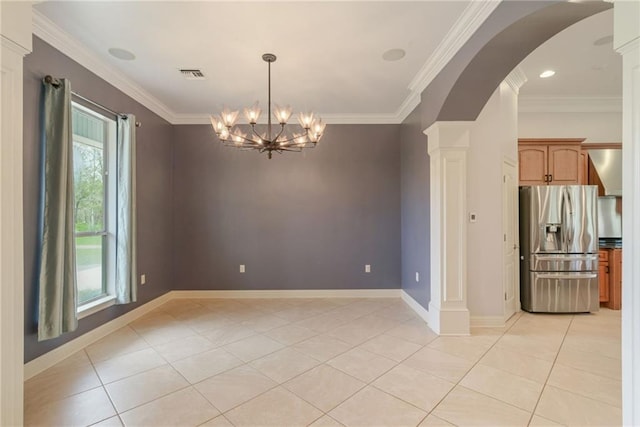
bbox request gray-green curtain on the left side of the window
[38,79,78,341]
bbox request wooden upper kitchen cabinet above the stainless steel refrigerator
[518,138,587,185]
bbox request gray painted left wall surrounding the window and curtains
[24,36,173,362]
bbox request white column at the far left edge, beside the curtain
[0,2,31,426]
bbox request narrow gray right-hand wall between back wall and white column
[400,106,431,309]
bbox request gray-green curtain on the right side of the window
[116,114,138,304]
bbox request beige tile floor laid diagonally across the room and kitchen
[25,298,622,427]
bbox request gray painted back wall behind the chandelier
[174,125,401,289]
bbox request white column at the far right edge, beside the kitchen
[613,0,640,426]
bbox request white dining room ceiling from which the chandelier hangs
[35,1,476,123]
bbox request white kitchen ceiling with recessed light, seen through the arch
[520,9,622,99]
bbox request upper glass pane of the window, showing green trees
[73,141,105,231]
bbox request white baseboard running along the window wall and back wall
[24,289,402,381]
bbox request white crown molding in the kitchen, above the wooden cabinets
[518,97,622,113]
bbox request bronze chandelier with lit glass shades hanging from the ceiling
[211,53,325,158]
